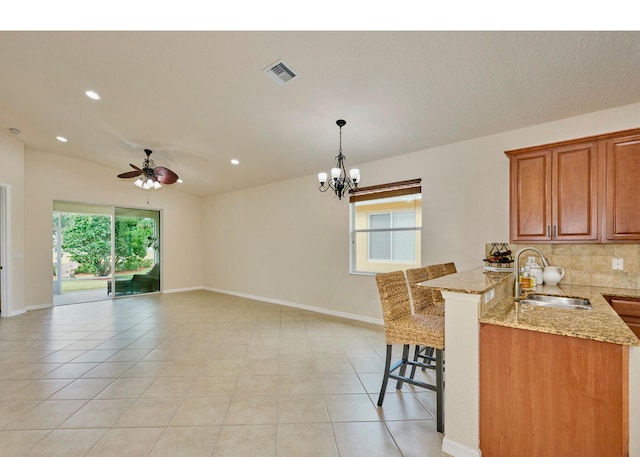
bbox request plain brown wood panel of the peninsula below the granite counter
[480,324,629,457]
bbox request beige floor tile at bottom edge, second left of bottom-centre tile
[149,427,220,457]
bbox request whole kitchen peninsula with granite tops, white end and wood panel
[421,268,640,457]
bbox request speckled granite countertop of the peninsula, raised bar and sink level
[421,268,640,346]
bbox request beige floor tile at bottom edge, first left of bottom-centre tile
[213,424,278,457]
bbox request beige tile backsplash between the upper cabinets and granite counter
[485,243,640,289]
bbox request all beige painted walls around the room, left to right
[0,100,640,322]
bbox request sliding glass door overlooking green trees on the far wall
[53,202,161,305]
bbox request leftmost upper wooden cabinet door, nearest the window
[510,151,552,241]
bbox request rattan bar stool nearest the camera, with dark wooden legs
[376,271,444,432]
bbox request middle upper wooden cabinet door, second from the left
[551,142,599,241]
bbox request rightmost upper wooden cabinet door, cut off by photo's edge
[606,135,640,241]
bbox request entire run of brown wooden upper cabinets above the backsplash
[505,125,640,243]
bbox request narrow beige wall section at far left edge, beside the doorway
[0,133,25,316]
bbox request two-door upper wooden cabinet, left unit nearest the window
[507,141,600,242]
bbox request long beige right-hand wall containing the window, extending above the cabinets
[204,104,640,321]
